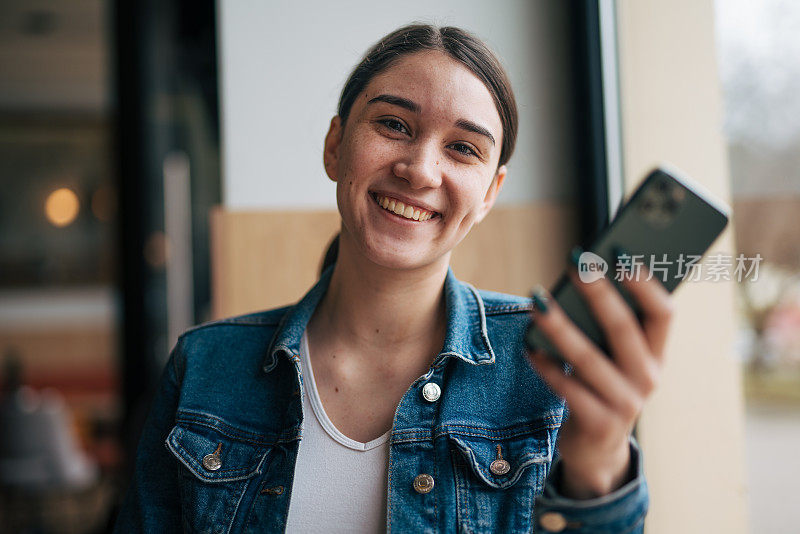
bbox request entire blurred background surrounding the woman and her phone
[0,0,800,534]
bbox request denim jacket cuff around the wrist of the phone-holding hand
[534,437,649,534]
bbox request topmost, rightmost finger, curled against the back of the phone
[621,265,675,362]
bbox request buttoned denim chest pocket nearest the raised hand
[448,429,552,533]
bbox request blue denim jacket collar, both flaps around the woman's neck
[262,266,494,372]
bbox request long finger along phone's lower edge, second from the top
[569,268,660,394]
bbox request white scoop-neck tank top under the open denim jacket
[286,332,391,534]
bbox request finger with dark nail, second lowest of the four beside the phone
[534,288,638,413]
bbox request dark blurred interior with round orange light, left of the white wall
[0,0,220,533]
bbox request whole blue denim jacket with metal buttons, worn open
[116,269,648,533]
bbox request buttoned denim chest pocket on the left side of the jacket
[166,422,270,533]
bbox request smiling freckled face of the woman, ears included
[324,51,506,269]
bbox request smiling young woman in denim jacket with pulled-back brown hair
[117,25,672,532]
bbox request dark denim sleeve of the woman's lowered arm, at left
[114,339,182,533]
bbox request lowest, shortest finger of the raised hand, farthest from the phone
[529,350,611,432]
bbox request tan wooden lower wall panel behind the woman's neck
[211,203,577,318]
